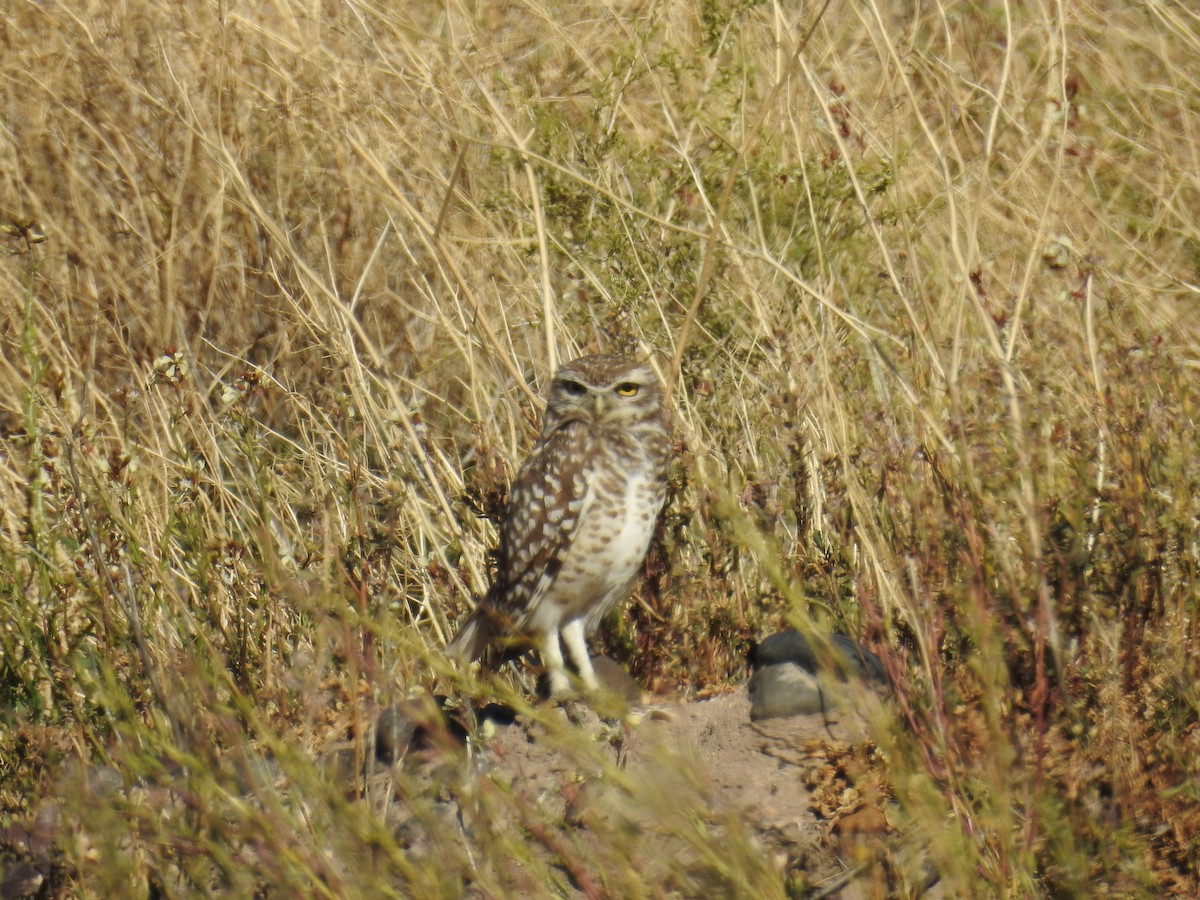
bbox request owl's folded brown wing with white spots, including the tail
[446,422,593,660]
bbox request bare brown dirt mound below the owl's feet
[372,686,937,900]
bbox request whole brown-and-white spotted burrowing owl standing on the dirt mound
[448,356,668,695]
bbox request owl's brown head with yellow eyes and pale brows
[544,355,662,432]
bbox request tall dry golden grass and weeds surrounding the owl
[0,0,1200,896]
